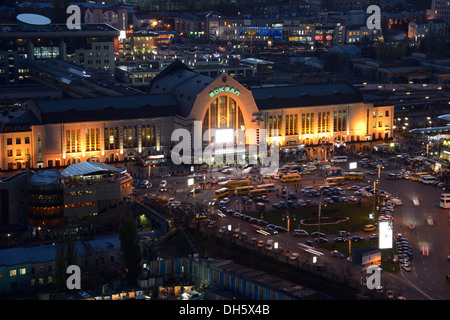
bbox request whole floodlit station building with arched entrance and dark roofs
[0,61,394,170]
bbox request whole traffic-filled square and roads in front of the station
[129,144,450,300]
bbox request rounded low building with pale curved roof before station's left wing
[24,162,133,228]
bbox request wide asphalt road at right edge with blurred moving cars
[381,179,450,300]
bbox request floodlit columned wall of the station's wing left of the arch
[27,117,167,168]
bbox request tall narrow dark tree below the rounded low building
[119,212,142,281]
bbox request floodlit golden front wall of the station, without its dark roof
[0,74,394,170]
